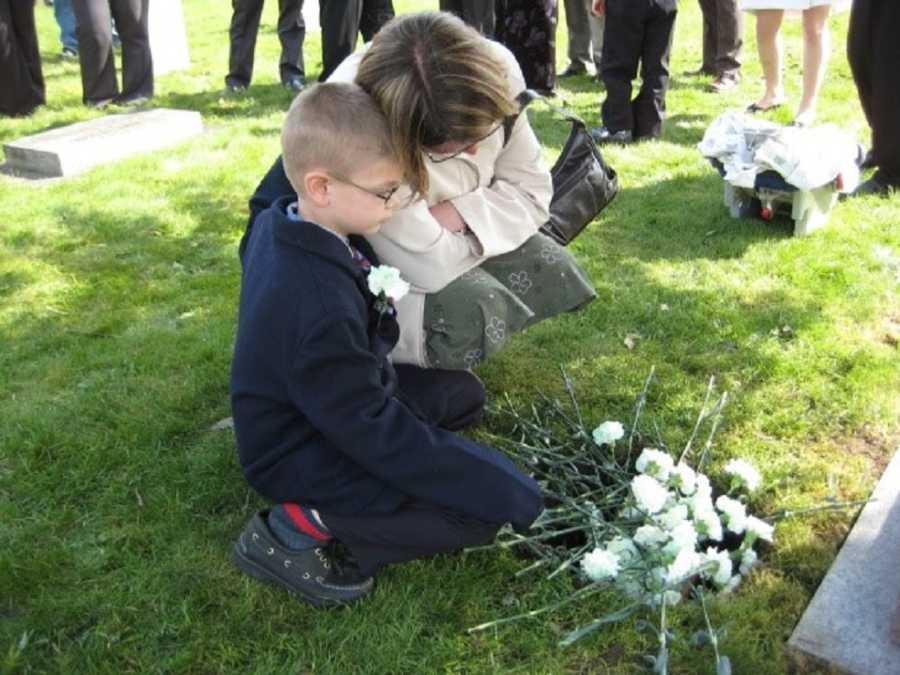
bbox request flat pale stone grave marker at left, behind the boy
[3,108,203,178]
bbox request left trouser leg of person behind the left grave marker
[72,0,119,103]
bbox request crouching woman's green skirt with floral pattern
[425,234,597,368]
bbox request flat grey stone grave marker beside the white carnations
[788,451,900,675]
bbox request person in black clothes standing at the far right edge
[847,0,900,196]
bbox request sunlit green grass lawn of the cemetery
[0,0,900,674]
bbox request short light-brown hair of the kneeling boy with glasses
[281,82,396,194]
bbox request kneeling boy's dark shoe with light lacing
[232,511,375,607]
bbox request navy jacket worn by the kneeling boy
[231,196,542,530]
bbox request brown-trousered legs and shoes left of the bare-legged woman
[696,0,744,94]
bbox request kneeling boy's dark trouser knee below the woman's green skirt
[394,364,485,431]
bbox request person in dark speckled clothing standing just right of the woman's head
[494,0,557,96]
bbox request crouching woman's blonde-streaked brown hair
[356,12,517,193]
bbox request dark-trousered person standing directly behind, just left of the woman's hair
[319,0,394,82]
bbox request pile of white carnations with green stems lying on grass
[470,371,774,675]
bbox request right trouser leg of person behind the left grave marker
[109,0,153,100]
